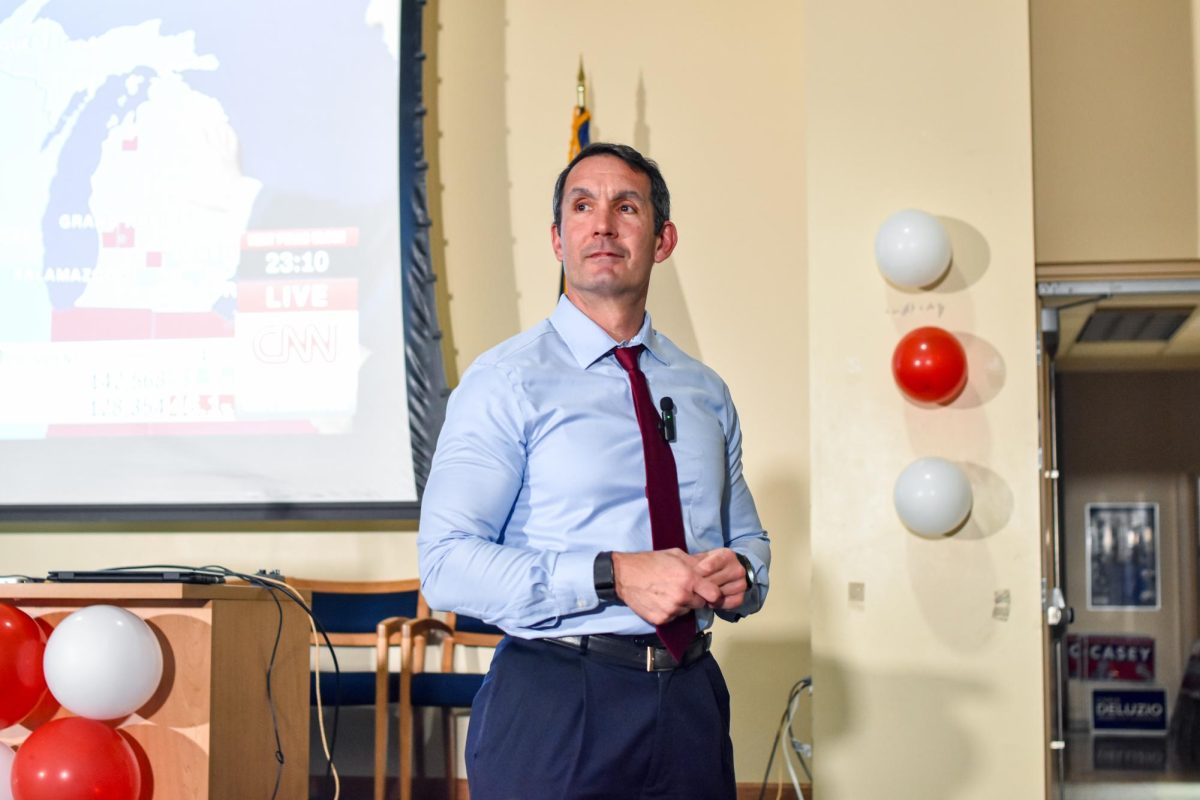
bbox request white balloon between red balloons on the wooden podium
[42,606,162,720]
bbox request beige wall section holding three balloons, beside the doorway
[803,0,1046,800]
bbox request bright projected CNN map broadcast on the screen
[0,0,400,440]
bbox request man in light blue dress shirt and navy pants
[418,144,770,800]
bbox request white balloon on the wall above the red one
[875,209,950,289]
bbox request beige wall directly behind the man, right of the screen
[430,0,810,782]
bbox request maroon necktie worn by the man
[614,344,696,662]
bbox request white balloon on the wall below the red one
[893,458,973,539]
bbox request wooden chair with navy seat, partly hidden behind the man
[400,599,504,800]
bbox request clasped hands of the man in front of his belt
[612,547,749,625]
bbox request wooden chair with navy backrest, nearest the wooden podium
[287,578,430,800]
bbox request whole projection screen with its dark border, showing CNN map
[0,0,445,521]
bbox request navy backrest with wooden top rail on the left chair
[287,578,428,646]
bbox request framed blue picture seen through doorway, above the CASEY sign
[1085,503,1162,610]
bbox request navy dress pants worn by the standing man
[467,637,737,800]
